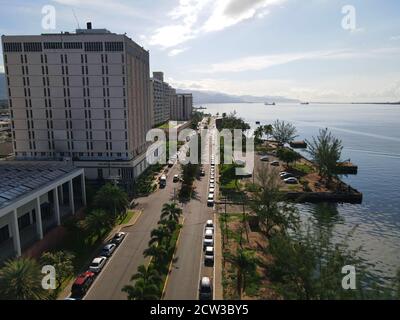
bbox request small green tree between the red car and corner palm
[40,251,75,290]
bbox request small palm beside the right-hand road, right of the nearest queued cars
[227,248,257,299]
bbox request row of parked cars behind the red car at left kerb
[67,232,126,300]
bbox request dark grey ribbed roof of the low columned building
[0,161,78,209]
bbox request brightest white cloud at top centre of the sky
[145,0,286,49]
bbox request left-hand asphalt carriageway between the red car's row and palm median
[85,164,183,300]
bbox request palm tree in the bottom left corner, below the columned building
[0,258,48,300]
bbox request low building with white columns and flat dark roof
[0,161,86,260]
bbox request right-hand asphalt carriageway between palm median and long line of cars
[164,120,214,300]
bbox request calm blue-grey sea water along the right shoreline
[203,104,400,280]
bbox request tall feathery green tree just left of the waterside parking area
[250,164,299,238]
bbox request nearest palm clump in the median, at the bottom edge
[122,265,161,300]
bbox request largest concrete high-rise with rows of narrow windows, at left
[2,23,157,180]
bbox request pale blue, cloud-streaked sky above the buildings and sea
[0,0,400,101]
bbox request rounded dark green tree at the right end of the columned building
[94,183,129,217]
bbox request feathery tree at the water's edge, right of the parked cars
[307,129,343,182]
